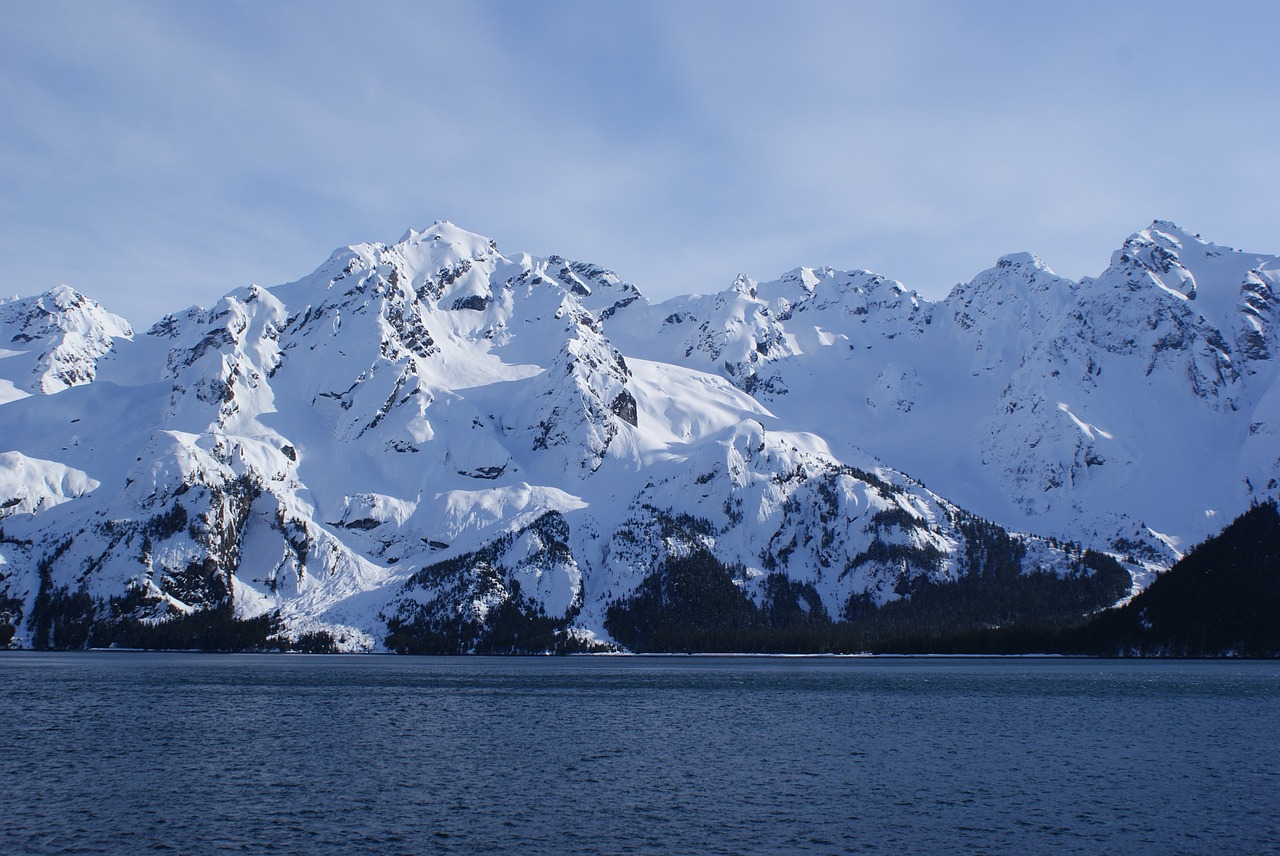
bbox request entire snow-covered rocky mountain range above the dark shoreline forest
[0,221,1280,650]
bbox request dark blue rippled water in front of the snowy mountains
[0,653,1280,853]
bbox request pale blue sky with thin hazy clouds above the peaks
[0,0,1280,326]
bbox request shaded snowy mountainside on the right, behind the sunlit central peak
[609,221,1280,564]
